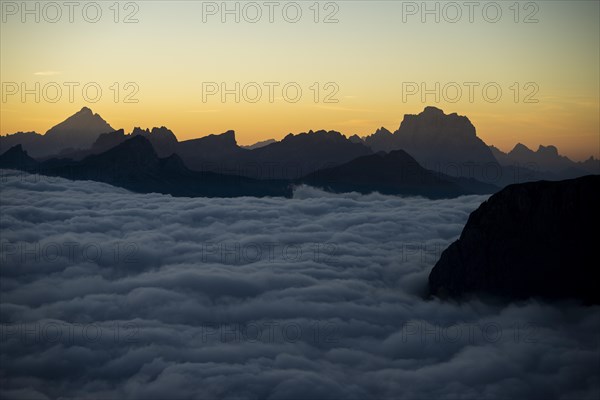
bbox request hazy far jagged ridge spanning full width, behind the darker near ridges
[0,107,600,186]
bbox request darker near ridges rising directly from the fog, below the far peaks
[0,132,497,198]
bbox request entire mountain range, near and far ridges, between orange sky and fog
[0,107,600,197]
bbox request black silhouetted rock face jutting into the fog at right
[429,175,600,304]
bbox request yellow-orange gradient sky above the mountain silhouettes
[0,1,600,160]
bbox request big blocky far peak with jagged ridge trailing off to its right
[363,107,600,186]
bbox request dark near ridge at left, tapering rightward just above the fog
[0,135,292,197]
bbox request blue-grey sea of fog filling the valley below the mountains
[0,171,600,399]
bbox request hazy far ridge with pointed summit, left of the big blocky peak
[5,107,371,179]
